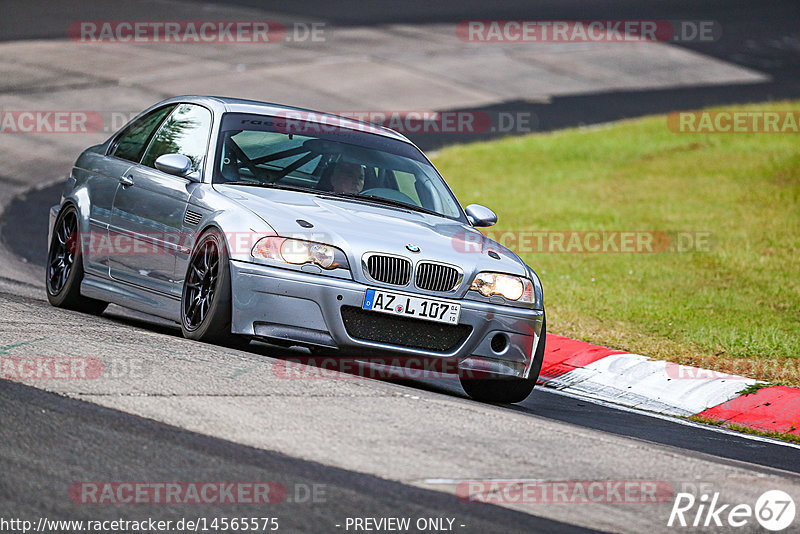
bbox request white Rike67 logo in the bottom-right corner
[667,490,795,532]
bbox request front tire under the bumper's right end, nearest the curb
[459,318,547,404]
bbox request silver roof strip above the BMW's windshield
[169,95,413,144]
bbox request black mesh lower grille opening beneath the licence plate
[342,306,472,352]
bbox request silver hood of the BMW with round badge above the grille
[214,185,527,286]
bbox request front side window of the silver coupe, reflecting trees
[142,104,211,172]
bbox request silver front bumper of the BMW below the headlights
[230,260,544,378]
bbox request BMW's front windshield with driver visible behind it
[214,113,463,220]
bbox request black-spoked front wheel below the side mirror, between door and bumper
[181,230,241,345]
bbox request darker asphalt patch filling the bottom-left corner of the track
[0,381,585,533]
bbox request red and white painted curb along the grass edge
[539,334,800,435]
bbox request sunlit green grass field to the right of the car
[435,102,800,386]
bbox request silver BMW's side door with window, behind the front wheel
[109,104,216,296]
